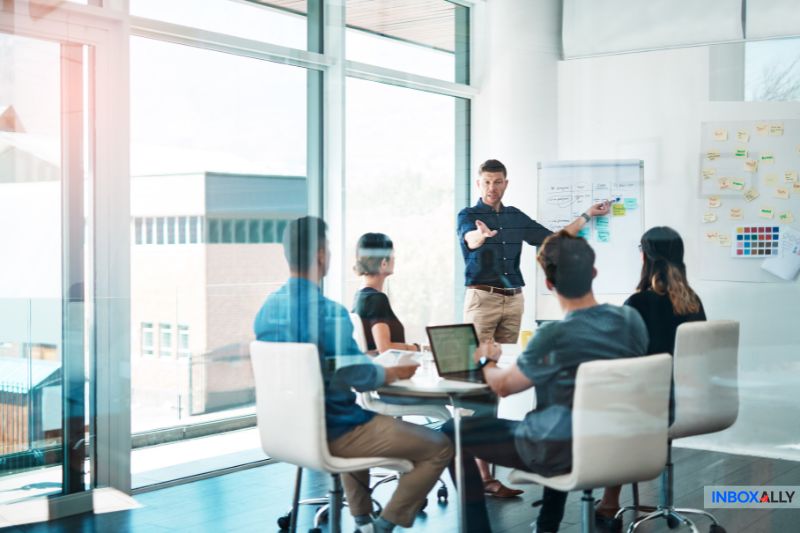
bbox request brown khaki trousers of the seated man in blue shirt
[328,415,453,527]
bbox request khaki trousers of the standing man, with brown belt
[464,289,525,344]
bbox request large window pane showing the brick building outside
[131,34,307,486]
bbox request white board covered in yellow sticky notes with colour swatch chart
[697,118,800,282]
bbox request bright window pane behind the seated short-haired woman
[345,79,457,342]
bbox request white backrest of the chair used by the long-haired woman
[669,320,739,438]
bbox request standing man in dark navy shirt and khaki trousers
[457,159,609,343]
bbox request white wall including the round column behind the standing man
[472,4,800,458]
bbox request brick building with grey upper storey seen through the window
[131,172,306,432]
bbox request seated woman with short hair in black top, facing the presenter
[353,233,523,498]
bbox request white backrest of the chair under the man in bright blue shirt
[250,341,330,471]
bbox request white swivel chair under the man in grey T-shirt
[509,354,671,533]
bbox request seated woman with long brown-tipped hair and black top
[596,226,706,530]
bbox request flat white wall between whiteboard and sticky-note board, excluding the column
[558,47,800,458]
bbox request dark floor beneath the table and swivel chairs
[10,449,800,533]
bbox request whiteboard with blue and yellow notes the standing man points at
[536,159,644,320]
